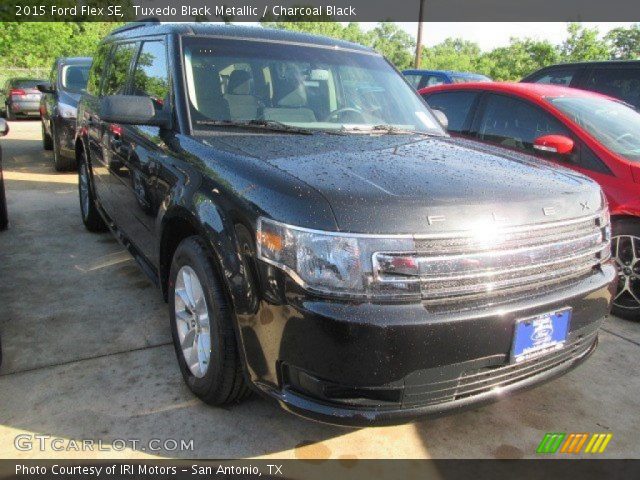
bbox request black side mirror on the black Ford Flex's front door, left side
[100,95,169,127]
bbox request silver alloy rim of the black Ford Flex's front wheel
[174,265,211,378]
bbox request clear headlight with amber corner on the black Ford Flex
[257,218,420,297]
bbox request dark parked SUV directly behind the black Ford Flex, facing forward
[38,57,91,171]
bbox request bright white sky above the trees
[361,22,633,51]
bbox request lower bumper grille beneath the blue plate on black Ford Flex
[403,331,597,407]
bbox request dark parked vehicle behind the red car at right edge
[522,60,640,108]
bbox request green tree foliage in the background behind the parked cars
[0,21,640,80]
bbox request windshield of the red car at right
[548,97,640,161]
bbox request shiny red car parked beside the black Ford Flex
[420,83,640,320]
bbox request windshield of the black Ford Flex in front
[184,38,444,135]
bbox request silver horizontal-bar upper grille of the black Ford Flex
[374,211,611,305]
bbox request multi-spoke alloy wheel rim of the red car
[611,235,640,310]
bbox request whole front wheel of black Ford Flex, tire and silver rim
[168,236,250,405]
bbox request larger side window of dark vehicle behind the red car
[583,67,640,107]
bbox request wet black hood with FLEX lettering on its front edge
[195,134,602,233]
